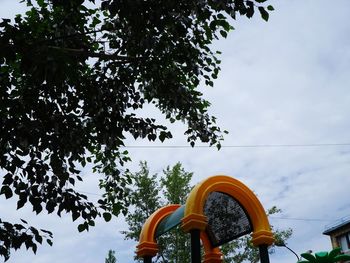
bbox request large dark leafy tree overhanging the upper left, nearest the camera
[0,0,273,259]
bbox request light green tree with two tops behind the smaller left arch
[122,162,193,263]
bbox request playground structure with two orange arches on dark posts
[136,175,274,263]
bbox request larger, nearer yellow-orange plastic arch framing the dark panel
[182,175,274,246]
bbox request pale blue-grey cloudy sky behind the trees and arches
[0,0,350,263]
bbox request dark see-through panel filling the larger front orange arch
[204,192,252,247]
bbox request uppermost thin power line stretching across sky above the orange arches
[124,143,350,149]
